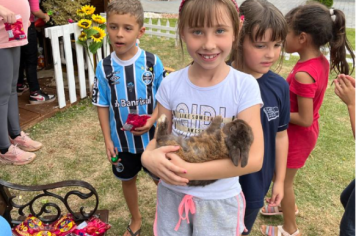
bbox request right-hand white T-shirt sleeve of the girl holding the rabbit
[237,75,263,114]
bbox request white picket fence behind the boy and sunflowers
[45,16,176,108]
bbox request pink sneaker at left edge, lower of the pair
[0,145,36,166]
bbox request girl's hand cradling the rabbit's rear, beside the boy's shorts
[141,146,189,186]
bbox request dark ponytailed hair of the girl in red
[286,2,355,74]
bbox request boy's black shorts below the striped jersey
[112,152,159,181]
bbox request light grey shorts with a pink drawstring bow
[153,184,246,236]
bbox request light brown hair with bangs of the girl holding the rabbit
[178,0,240,55]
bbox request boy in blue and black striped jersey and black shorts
[92,0,164,236]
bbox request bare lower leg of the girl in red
[281,168,298,234]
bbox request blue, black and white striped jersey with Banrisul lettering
[92,48,165,153]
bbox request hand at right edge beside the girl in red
[334,74,355,106]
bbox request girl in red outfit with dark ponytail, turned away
[261,2,355,236]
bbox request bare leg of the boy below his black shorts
[122,176,142,236]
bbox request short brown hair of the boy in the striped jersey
[106,0,144,27]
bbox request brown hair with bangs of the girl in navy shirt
[229,0,288,71]
